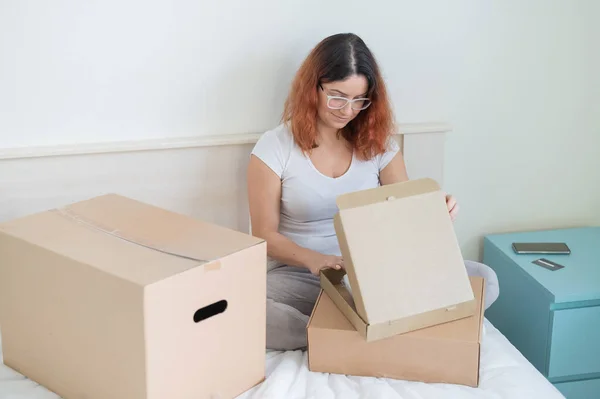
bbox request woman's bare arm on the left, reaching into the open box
[247,155,343,274]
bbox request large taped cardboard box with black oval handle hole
[0,195,266,399]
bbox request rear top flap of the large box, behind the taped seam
[55,194,262,262]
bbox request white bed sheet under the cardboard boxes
[0,320,564,399]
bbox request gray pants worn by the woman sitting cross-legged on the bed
[267,261,500,350]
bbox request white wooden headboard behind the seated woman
[0,123,450,232]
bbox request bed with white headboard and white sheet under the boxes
[0,123,563,399]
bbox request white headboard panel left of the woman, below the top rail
[0,144,252,231]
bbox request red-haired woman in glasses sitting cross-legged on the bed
[248,34,497,350]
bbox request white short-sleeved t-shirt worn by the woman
[252,124,400,270]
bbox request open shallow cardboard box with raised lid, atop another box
[321,179,476,342]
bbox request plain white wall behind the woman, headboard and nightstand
[0,0,600,258]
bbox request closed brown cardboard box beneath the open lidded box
[307,277,484,387]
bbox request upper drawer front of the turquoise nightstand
[548,306,600,378]
